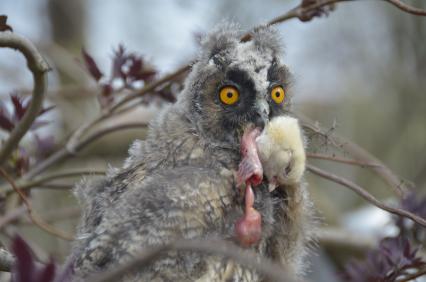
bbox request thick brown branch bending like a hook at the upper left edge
[0,32,50,166]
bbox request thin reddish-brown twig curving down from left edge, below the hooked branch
[0,168,74,240]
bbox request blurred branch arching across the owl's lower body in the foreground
[87,239,296,282]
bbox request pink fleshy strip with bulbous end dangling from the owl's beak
[235,128,263,247]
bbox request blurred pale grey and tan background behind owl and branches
[0,0,426,281]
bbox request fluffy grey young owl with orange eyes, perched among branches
[69,24,314,281]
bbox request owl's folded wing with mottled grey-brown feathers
[75,167,235,281]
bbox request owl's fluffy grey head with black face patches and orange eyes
[180,24,290,147]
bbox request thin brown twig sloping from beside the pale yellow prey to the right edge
[306,165,426,228]
